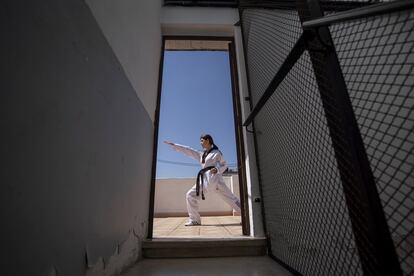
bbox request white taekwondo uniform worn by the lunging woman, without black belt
[171,144,240,224]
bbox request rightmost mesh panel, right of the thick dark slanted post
[330,10,414,275]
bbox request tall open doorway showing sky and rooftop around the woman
[148,37,249,238]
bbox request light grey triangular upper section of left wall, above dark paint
[86,0,162,123]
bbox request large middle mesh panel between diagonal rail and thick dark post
[255,50,362,275]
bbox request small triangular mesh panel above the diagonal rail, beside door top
[242,9,302,104]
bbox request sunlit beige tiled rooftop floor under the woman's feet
[153,216,243,238]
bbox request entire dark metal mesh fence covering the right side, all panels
[240,1,414,275]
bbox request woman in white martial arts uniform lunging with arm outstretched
[164,134,240,226]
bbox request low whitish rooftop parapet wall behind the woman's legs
[154,175,240,217]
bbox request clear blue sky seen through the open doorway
[157,51,237,178]
